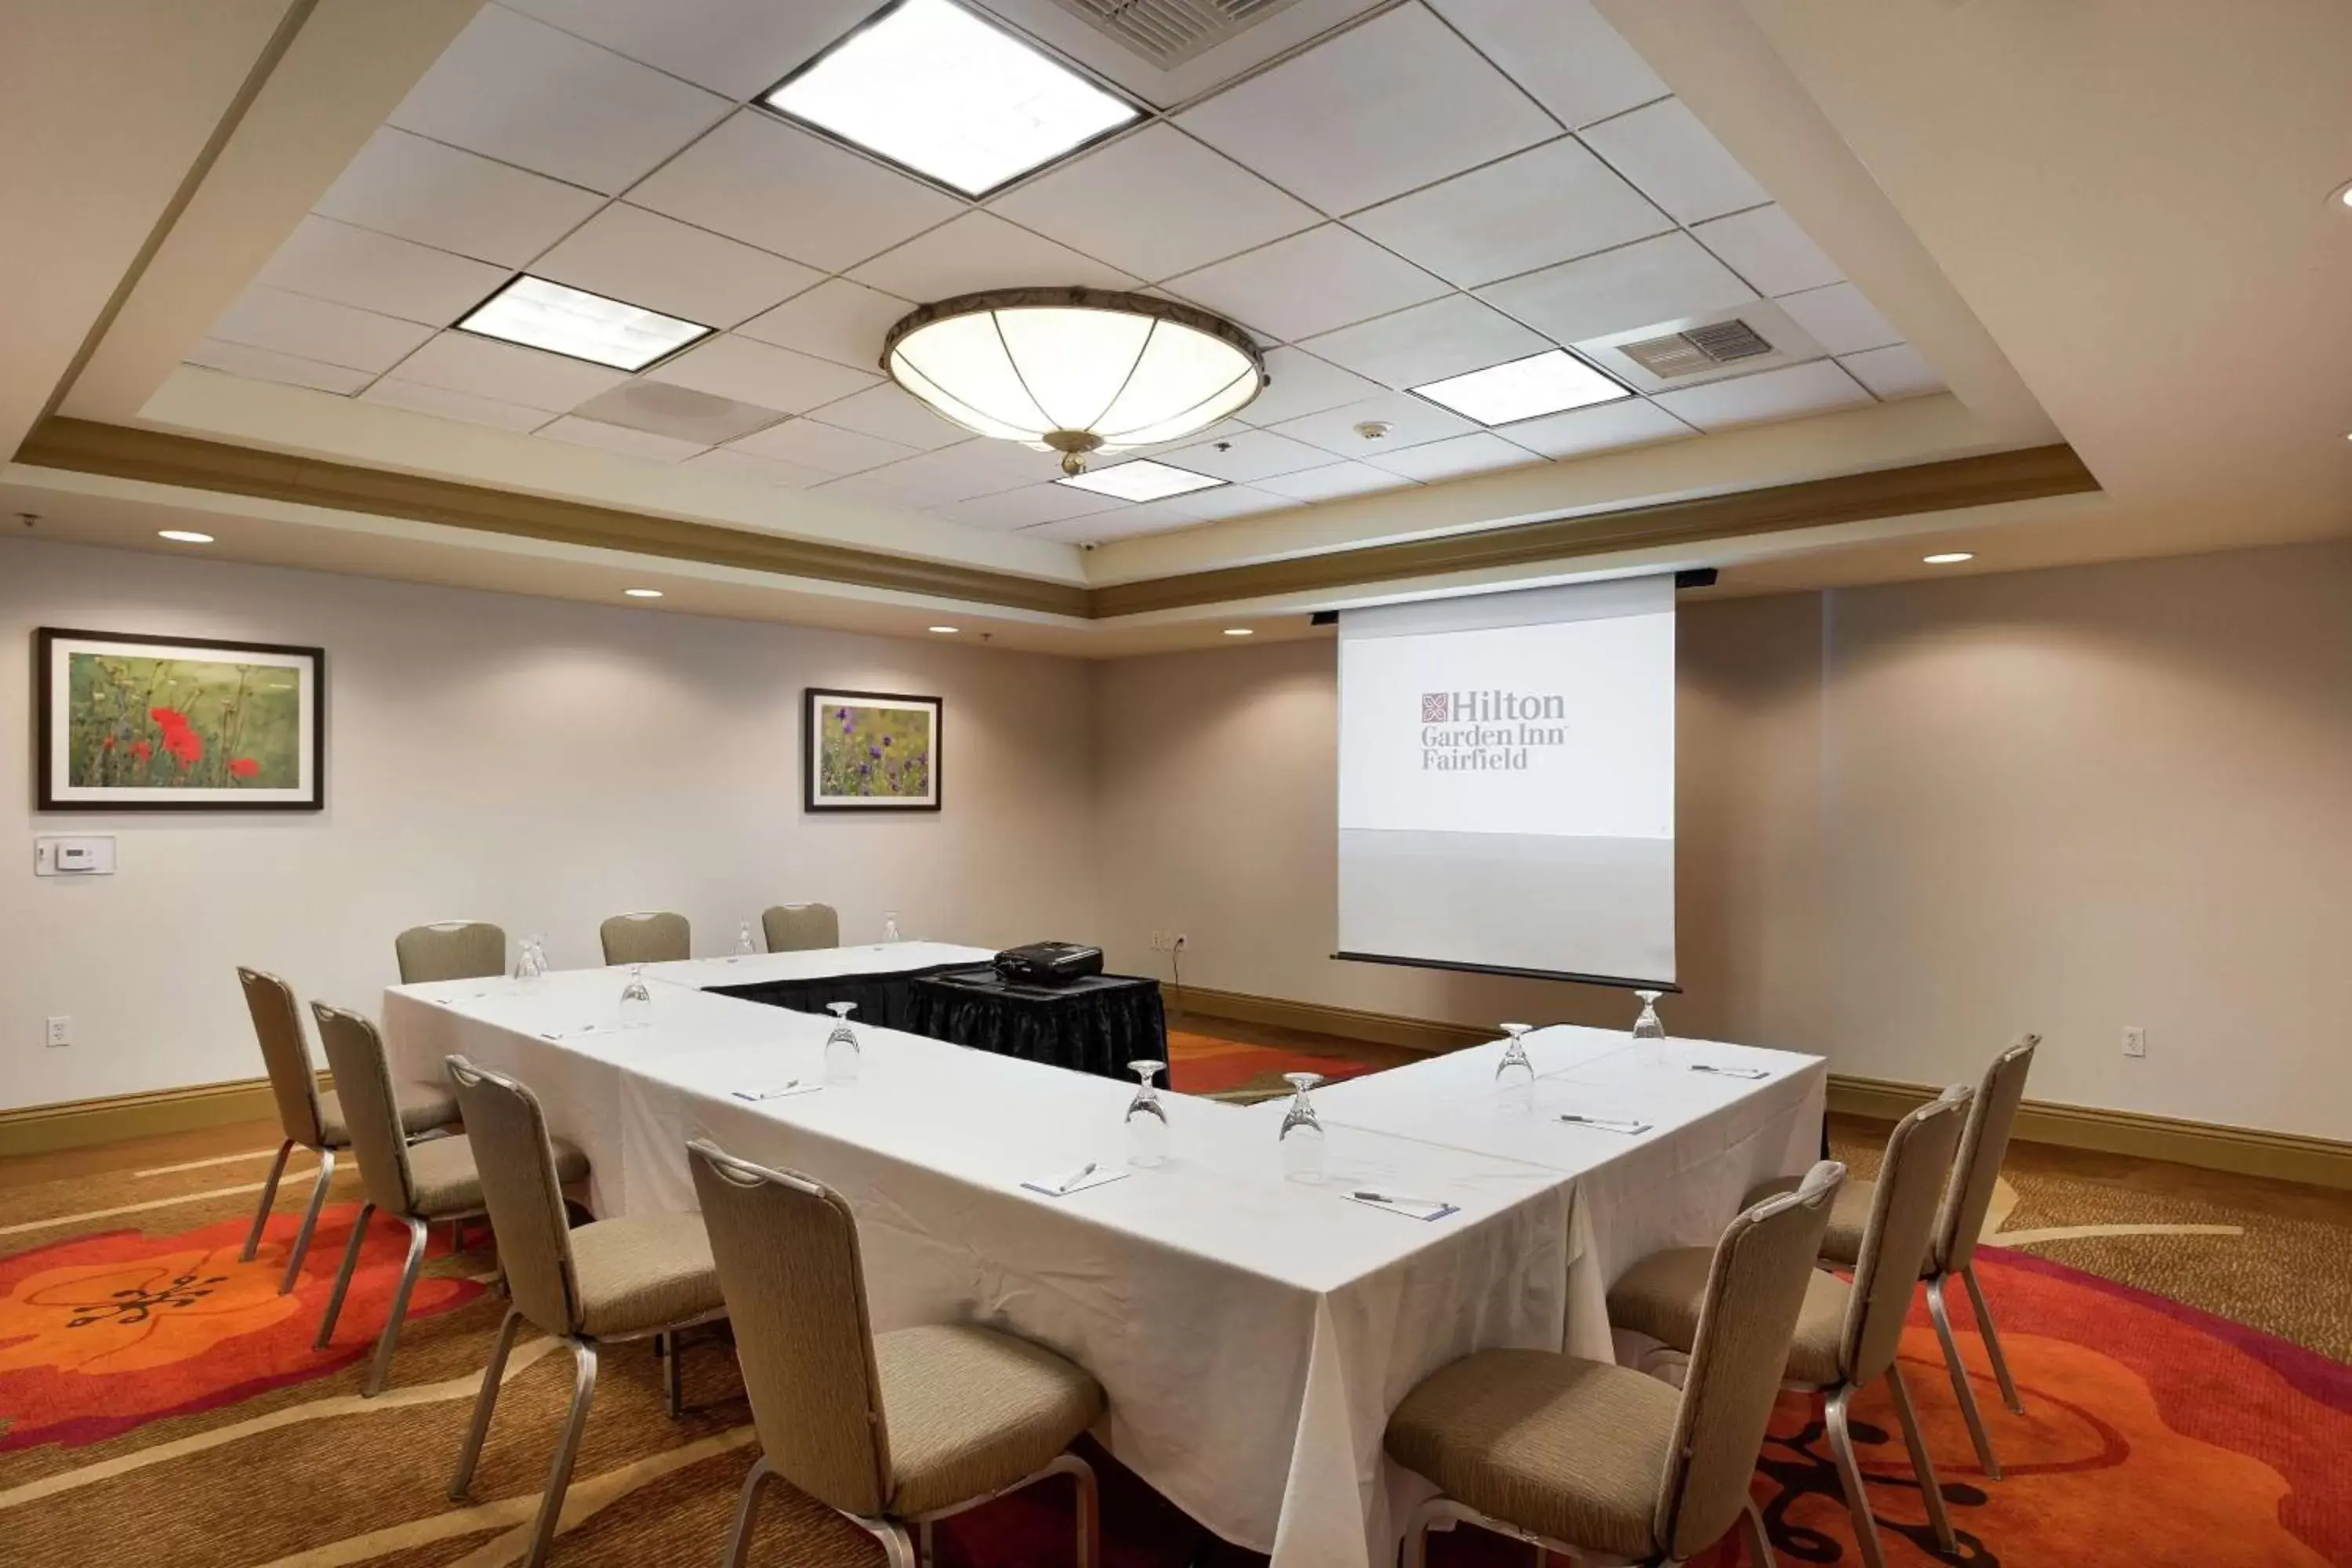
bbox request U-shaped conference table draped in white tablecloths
[383,942,1828,1568]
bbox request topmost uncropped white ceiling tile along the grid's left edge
[390,5,729,195]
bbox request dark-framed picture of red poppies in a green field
[33,626,327,811]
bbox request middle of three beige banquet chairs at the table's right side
[1609,1083,1973,1568]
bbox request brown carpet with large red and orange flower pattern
[0,1046,2352,1568]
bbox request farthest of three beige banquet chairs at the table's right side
[1750,1034,2042,1481]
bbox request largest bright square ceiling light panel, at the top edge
[762,0,1136,195]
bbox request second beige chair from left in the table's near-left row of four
[310,1001,588,1399]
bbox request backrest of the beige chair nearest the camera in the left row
[687,1140,891,1519]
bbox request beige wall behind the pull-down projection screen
[1094,546,2352,1138]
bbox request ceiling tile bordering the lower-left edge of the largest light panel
[628,108,964,273]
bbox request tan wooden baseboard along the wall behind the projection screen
[1183,987,2352,1189]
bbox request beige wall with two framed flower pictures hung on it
[0,541,1094,1107]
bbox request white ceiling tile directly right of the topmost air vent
[1176,5,1559,216]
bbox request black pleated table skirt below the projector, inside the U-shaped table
[713,964,1169,1081]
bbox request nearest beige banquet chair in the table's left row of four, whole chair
[687,1142,1103,1568]
